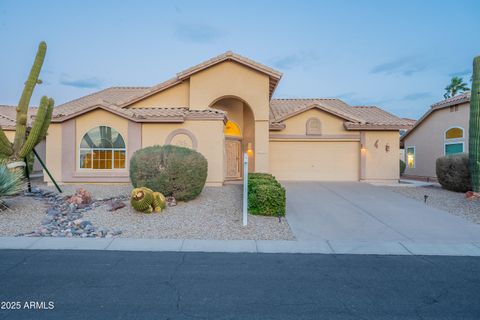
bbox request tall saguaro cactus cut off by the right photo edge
[468,56,480,192]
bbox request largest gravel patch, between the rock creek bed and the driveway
[84,185,294,240]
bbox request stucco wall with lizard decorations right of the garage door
[360,131,400,182]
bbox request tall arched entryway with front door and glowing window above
[210,96,255,180]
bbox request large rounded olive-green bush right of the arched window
[130,145,208,201]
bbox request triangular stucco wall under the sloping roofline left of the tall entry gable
[129,80,190,108]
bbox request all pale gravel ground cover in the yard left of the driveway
[0,184,294,240]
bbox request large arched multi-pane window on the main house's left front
[80,126,126,169]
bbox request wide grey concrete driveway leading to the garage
[283,182,480,243]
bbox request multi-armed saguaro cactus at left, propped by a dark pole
[0,41,54,168]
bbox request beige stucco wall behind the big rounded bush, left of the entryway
[142,120,225,186]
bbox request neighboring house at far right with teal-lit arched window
[401,92,470,179]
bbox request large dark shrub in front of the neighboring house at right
[436,153,471,192]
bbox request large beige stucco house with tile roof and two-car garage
[0,52,409,186]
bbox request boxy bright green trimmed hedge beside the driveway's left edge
[248,173,286,217]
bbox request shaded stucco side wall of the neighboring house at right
[403,103,470,178]
